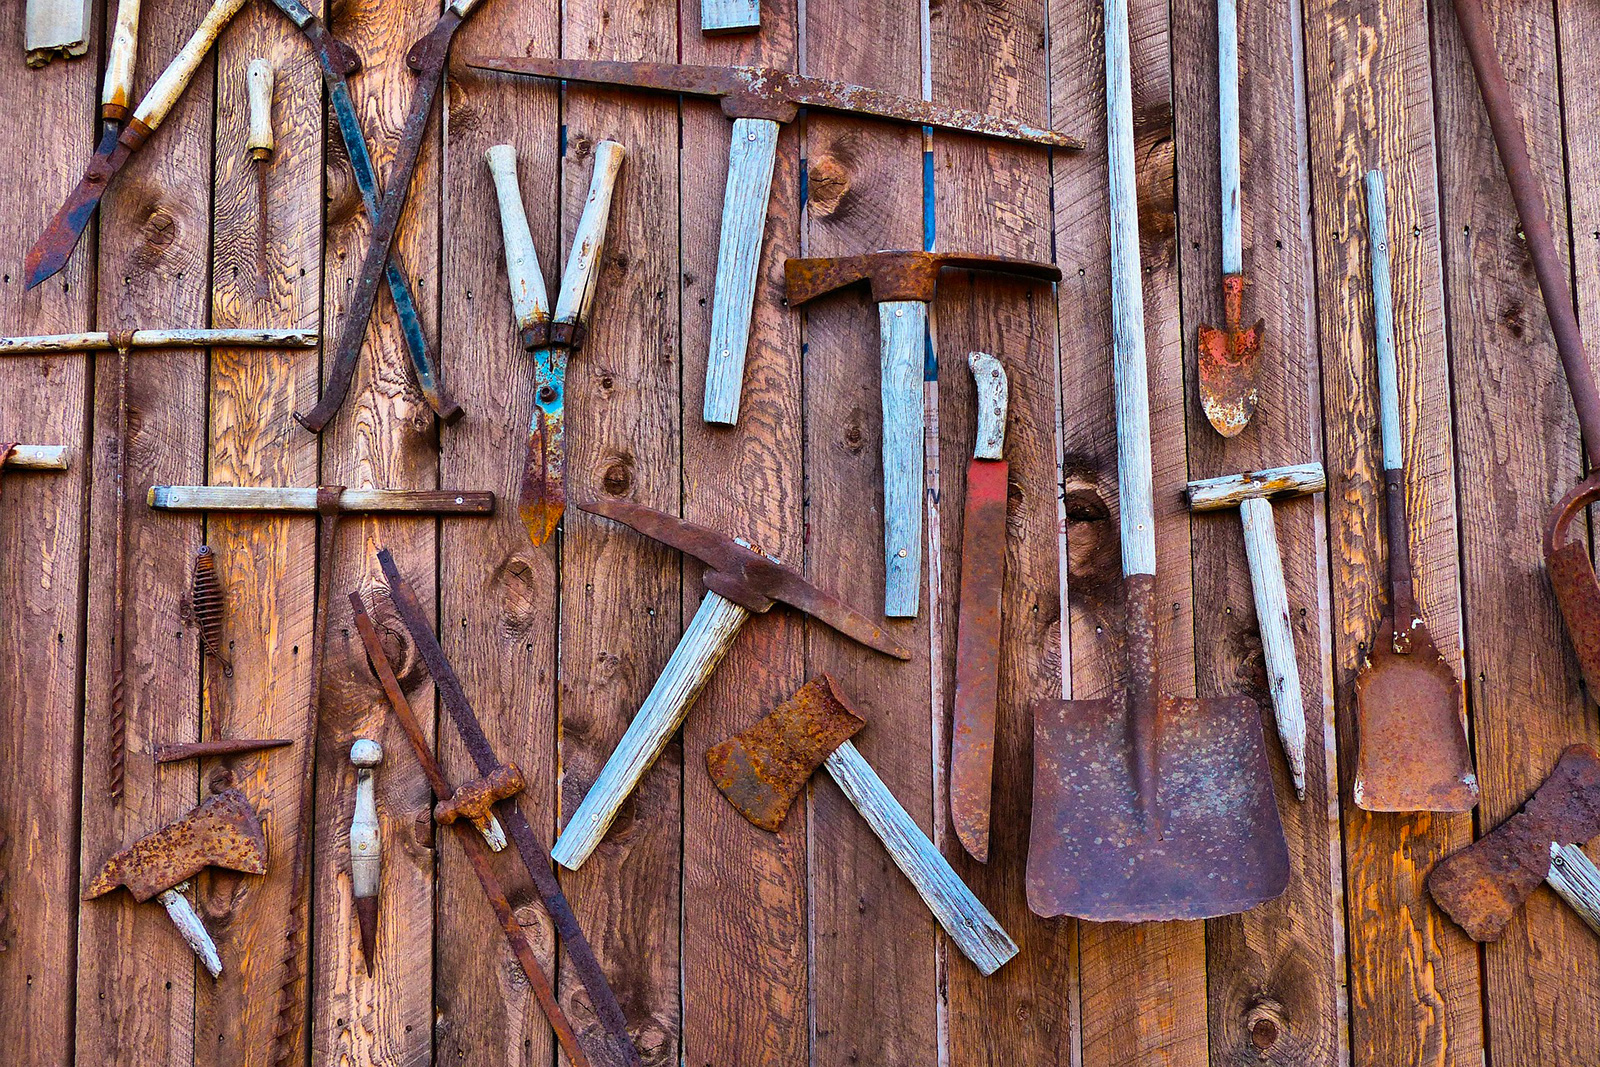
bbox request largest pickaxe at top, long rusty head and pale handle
[467,56,1083,426]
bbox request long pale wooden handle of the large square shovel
[1106,0,1155,574]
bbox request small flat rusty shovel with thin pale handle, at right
[1352,171,1478,811]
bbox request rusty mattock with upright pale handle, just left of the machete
[784,251,1061,617]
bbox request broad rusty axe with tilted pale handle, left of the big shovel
[706,673,1018,974]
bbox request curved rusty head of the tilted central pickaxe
[578,498,910,659]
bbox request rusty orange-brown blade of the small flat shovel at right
[1352,614,1472,809]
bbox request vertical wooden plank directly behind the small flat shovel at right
[1306,0,1483,1067]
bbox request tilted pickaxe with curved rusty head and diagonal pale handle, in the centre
[550,499,910,870]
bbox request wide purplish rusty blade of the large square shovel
[1027,694,1290,923]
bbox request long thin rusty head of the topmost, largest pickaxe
[466,56,1083,149]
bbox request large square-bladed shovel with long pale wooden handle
[1027,0,1290,921]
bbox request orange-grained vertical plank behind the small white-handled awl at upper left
[196,5,323,1064]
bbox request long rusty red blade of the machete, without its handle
[950,459,1010,862]
